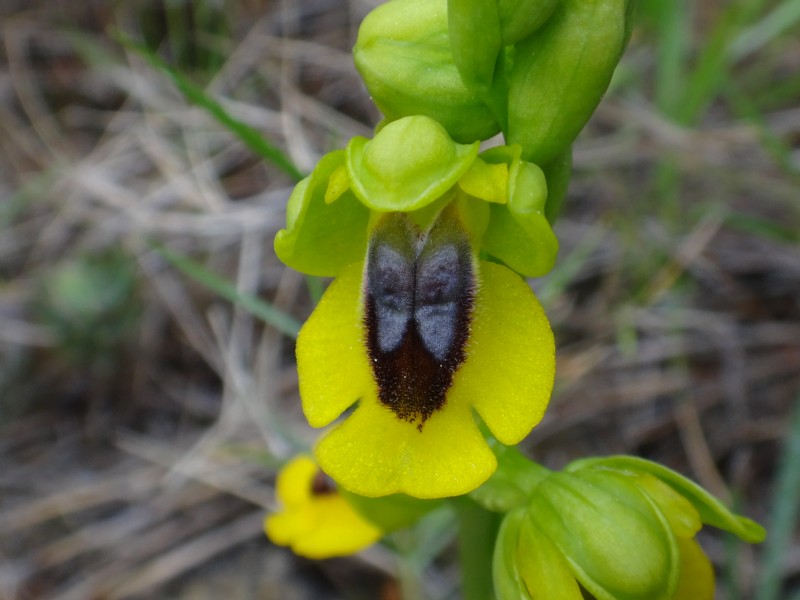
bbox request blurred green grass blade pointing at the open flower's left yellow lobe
[155,246,300,337]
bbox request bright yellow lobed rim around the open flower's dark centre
[297,252,555,498]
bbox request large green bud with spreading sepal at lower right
[490,454,764,600]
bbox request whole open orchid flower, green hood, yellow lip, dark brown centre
[276,117,556,498]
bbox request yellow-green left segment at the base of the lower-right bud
[517,519,583,600]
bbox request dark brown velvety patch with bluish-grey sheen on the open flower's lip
[365,213,475,430]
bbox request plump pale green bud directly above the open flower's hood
[353,0,500,143]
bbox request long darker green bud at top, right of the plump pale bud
[508,0,633,164]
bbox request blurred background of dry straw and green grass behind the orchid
[0,0,800,600]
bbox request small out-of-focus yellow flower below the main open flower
[264,456,382,559]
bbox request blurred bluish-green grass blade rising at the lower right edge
[756,396,800,600]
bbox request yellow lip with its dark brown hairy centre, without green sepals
[297,207,555,498]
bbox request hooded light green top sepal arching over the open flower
[347,116,479,212]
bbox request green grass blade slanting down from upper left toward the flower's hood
[117,34,303,181]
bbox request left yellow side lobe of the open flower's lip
[296,262,375,427]
